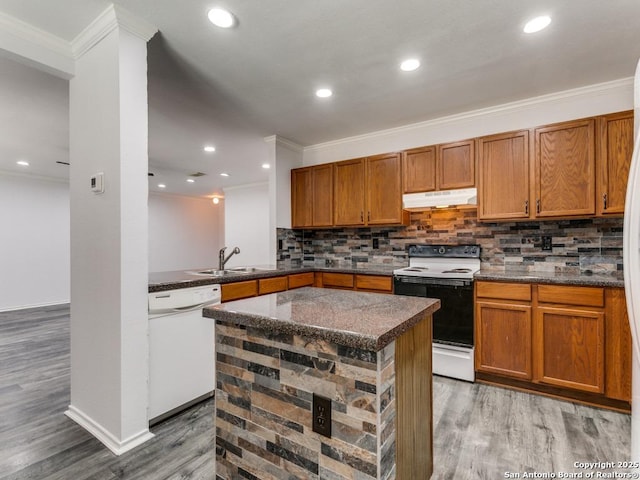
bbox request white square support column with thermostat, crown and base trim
[66,5,156,454]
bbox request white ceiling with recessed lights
[0,0,640,195]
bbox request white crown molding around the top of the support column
[71,4,158,59]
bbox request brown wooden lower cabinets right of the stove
[475,281,631,410]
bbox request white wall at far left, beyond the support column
[0,175,70,310]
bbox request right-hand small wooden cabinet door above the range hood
[437,140,476,190]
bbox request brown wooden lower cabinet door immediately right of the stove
[476,300,532,380]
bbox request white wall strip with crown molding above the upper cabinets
[304,78,633,166]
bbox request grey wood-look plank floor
[0,306,631,480]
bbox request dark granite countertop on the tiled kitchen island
[204,287,440,351]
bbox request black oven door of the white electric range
[393,276,474,347]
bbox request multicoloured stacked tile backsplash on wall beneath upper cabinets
[278,208,623,273]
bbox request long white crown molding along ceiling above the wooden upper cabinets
[303,77,633,153]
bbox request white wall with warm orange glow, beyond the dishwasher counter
[149,194,224,272]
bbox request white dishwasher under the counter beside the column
[148,284,221,425]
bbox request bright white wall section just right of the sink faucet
[224,183,271,267]
